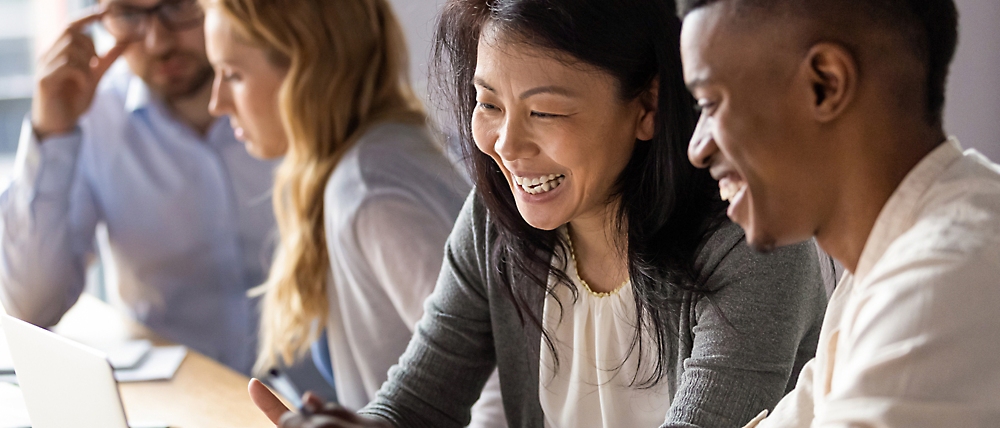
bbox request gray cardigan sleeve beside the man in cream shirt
[664,225,826,428]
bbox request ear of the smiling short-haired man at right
[805,43,858,122]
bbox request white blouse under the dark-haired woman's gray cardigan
[538,232,670,428]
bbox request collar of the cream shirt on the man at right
[854,137,962,281]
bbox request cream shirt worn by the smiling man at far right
[748,139,1000,428]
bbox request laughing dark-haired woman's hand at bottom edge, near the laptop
[248,379,394,428]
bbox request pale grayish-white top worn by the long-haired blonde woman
[323,123,507,427]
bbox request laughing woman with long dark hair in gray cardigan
[260,0,826,428]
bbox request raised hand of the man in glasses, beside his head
[31,11,128,141]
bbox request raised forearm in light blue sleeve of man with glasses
[0,121,97,326]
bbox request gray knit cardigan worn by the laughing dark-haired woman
[361,193,826,428]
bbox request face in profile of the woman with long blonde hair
[205,9,288,159]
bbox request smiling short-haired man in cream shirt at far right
[681,0,1000,427]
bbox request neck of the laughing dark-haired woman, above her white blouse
[569,205,628,293]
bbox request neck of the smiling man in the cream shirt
[816,116,944,272]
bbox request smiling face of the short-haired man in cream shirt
[681,2,837,251]
